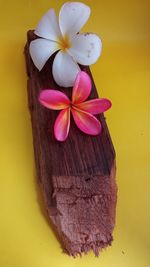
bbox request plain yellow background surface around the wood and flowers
[0,0,150,267]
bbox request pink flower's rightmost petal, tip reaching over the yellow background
[76,98,111,115]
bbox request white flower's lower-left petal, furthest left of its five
[29,39,59,71]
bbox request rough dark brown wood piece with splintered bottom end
[25,31,117,256]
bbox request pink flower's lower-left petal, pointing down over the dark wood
[54,108,70,141]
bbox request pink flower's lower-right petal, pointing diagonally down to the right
[71,108,101,135]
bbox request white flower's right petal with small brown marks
[69,33,102,66]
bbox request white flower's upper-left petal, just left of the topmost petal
[35,8,62,41]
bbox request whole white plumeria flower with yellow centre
[29,2,102,87]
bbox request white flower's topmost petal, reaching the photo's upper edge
[59,2,91,36]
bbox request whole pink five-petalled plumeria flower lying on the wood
[39,71,111,141]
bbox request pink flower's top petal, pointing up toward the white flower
[72,71,92,103]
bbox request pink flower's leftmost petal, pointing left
[39,90,70,110]
